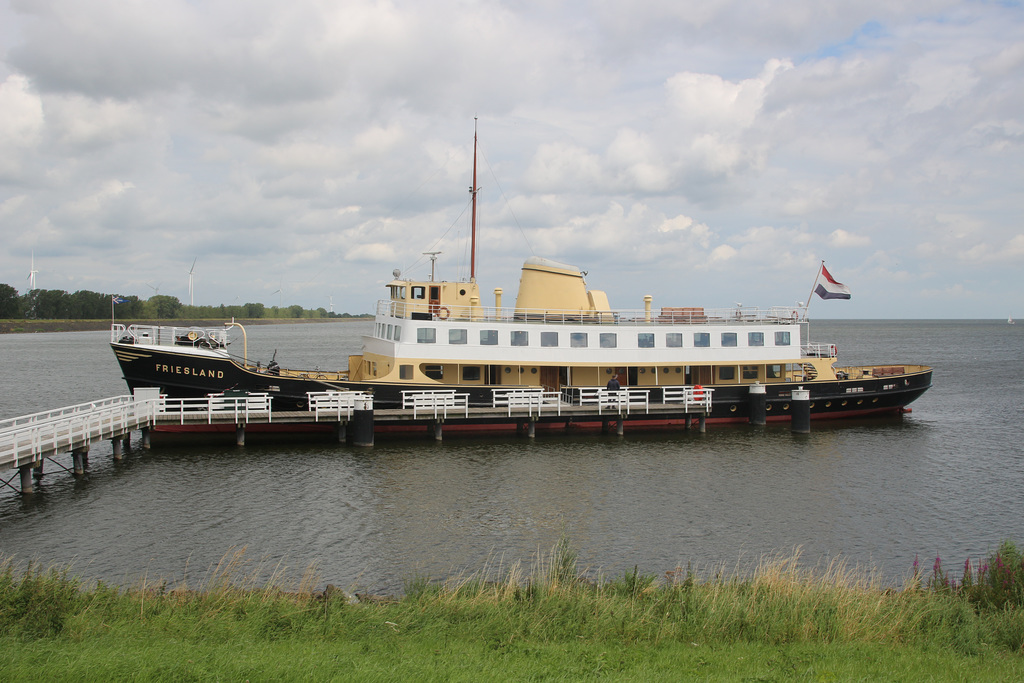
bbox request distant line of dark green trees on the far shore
[0,285,368,321]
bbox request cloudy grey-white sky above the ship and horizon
[0,0,1024,318]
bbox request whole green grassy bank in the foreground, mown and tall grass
[0,542,1024,681]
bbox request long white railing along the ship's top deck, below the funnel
[377,299,803,326]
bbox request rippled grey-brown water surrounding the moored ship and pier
[0,321,1024,593]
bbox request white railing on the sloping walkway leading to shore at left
[0,396,157,469]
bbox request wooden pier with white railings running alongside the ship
[0,387,712,494]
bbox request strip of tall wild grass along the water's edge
[0,541,1024,654]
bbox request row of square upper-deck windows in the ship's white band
[399,325,791,348]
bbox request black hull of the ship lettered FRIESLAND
[111,343,932,422]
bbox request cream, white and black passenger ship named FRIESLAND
[111,135,932,422]
